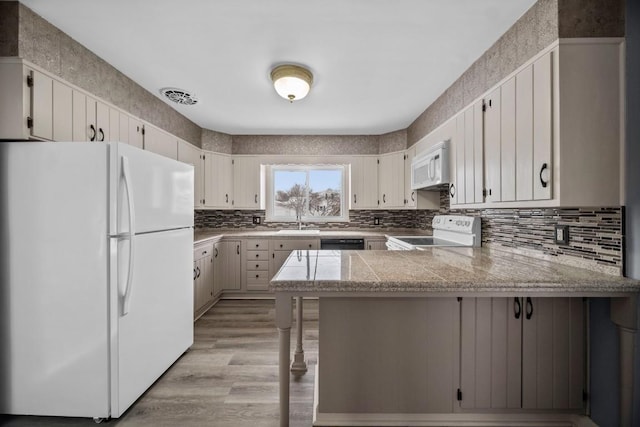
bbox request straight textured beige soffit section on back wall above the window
[233,135,378,156]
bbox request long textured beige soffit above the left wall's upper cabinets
[8,2,201,147]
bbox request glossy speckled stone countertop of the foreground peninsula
[270,248,640,296]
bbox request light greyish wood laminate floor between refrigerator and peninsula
[0,300,318,427]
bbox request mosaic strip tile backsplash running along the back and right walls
[195,191,623,274]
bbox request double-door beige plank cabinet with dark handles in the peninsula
[458,297,586,412]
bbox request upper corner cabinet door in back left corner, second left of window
[202,151,233,209]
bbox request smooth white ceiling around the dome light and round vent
[21,0,535,135]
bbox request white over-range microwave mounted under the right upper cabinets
[411,141,449,190]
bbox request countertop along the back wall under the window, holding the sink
[193,228,427,243]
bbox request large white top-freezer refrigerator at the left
[0,142,193,418]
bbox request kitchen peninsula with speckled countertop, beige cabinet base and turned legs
[270,248,640,426]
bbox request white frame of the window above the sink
[265,164,350,223]
